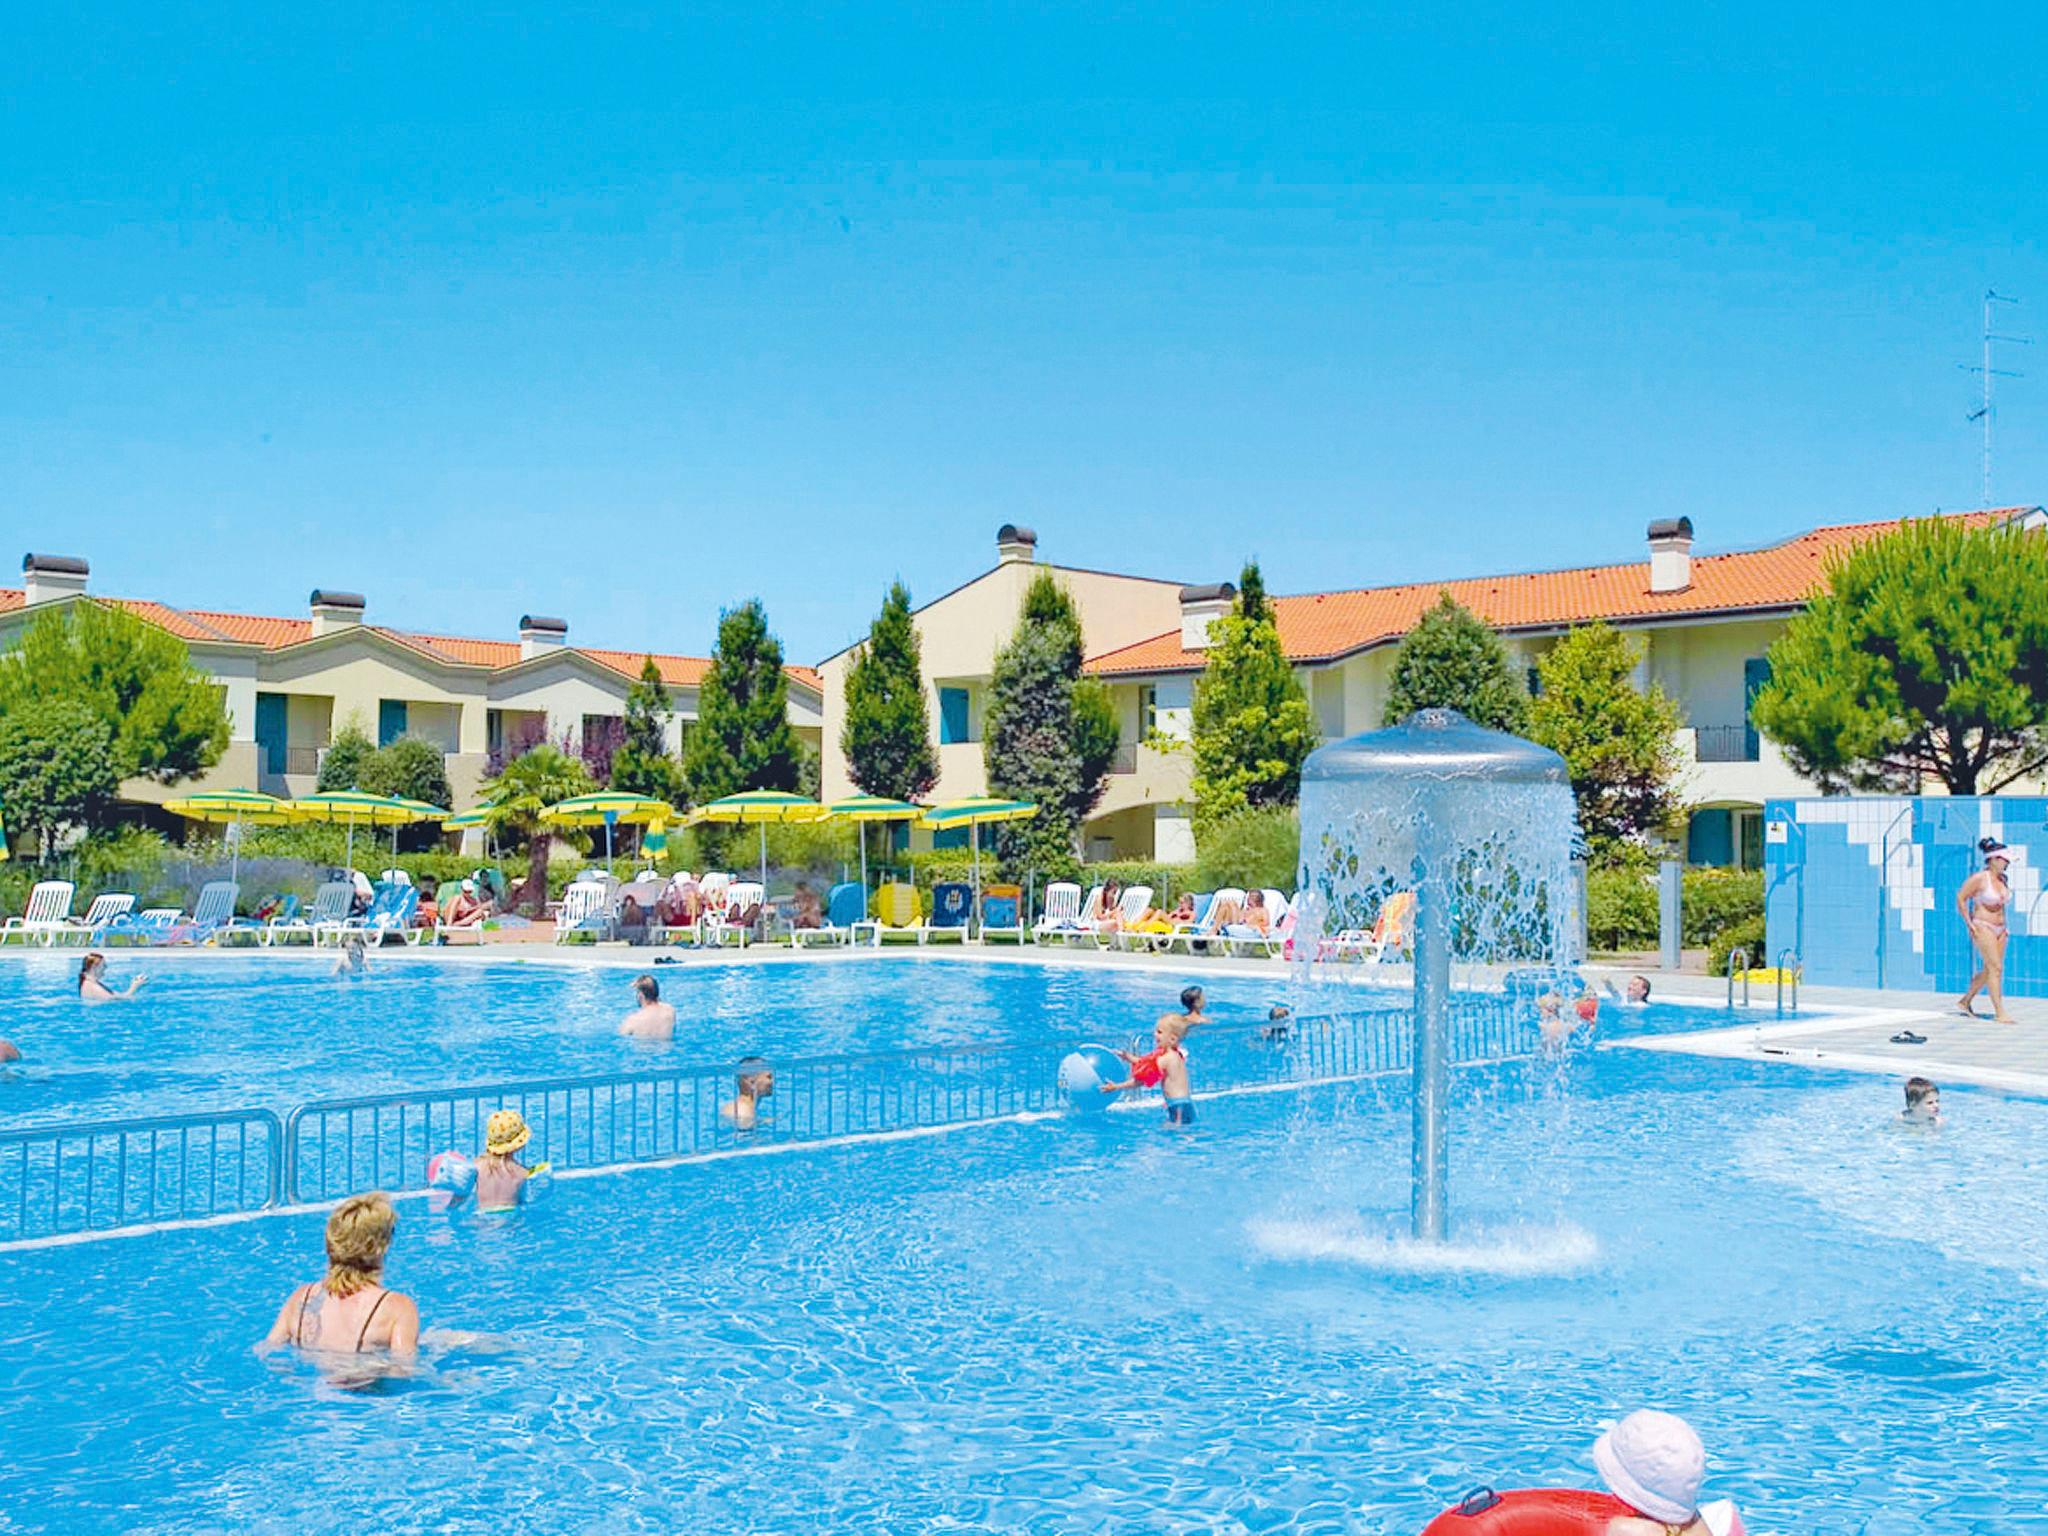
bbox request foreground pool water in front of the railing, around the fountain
[0,1040,2048,1536]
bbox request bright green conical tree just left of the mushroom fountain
[1194,561,1315,834]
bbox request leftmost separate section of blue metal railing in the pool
[0,1110,285,1243]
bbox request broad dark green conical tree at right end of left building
[682,598,801,805]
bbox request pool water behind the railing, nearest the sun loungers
[0,952,1733,1126]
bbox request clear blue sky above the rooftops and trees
[0,4,2048,662]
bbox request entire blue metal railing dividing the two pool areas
[0,997,1536,1243]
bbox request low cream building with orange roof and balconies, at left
[0,555,823,807]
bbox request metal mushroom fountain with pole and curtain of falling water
[1296,709,1579,1243]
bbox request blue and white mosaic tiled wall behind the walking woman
[1763,795,2048,997]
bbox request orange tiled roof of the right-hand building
[1087,508,2023,676]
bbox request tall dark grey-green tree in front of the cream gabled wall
[981,571,1118,877]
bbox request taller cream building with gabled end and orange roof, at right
[819,508,2042,868]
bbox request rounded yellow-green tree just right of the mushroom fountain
[1530,623,1681,860]
